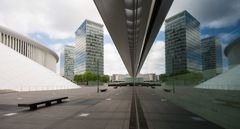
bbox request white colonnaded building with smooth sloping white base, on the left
[0,26,80,91]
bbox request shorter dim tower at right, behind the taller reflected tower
[201,37,222,74]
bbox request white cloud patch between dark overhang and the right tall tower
[140,41,165,74]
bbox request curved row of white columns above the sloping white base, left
[0,26,58,72]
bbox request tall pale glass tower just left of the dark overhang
[74,20,103,75]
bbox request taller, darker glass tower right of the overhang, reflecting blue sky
[165,11,202,75]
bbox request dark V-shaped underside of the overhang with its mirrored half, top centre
[94,0,173,77]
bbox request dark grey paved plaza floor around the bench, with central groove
[0,87,221,129]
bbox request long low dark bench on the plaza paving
[18,97,68,110]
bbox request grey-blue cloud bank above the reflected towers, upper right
[167,0,240,28]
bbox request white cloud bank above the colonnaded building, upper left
[0,0,108,39]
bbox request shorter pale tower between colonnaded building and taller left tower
[60,45,75,80]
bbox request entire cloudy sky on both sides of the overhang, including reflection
[0,0,240,75]
